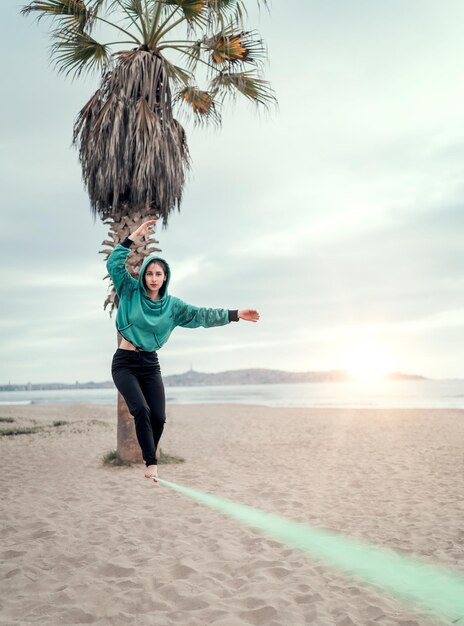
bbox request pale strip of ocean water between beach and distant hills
[0,380,464,409]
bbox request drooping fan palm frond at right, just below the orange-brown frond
[211,70,277,107]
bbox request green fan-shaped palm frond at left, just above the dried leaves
[51,29,111,78]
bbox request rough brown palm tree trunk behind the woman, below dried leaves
[101,212,161,463]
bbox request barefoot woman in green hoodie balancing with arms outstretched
[106,220,259,480]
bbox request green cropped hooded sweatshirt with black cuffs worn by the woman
[106,238,238,352]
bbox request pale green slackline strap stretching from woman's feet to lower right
[158,478,464,623]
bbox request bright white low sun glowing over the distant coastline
[343,334,393,381]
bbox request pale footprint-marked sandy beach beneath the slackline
[0,404,464,626]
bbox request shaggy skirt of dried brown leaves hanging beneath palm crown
[74,49,189,224]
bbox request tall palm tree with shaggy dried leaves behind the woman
[22,0,275,460]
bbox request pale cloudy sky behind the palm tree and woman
[0,0,464,384]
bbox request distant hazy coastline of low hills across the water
[0,368,429,391]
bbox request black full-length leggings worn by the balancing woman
[111,348,166,466]
